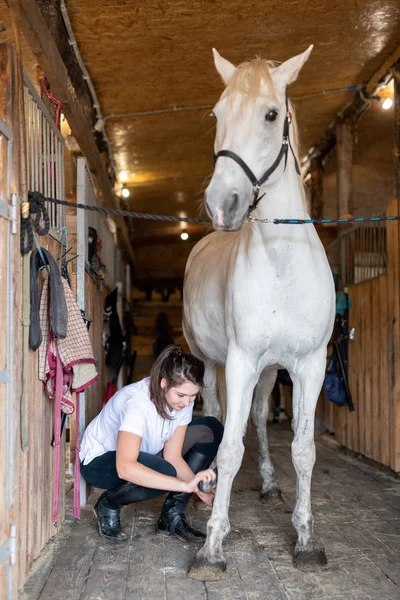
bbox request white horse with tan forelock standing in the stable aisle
[183,46,335,580]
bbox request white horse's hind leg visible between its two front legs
[251,369,282,503]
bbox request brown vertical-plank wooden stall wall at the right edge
[319,200,400,472]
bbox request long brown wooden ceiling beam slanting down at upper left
[6,0,134,262]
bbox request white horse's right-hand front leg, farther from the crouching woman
[290,349,327,569]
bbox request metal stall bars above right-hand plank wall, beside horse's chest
[326,221,387,288]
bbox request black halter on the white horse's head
[214,94,300,215]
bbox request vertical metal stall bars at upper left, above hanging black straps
[24,73,65,240]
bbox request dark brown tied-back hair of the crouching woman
[150,345,204,419]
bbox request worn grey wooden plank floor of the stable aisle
[21,425,400,600]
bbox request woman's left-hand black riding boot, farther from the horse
[94,481,146,542]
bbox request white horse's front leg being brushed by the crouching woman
[188,350,258,581]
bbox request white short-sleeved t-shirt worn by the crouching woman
[79,377,193,465]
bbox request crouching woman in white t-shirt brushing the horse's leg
[80,346,223,542]
